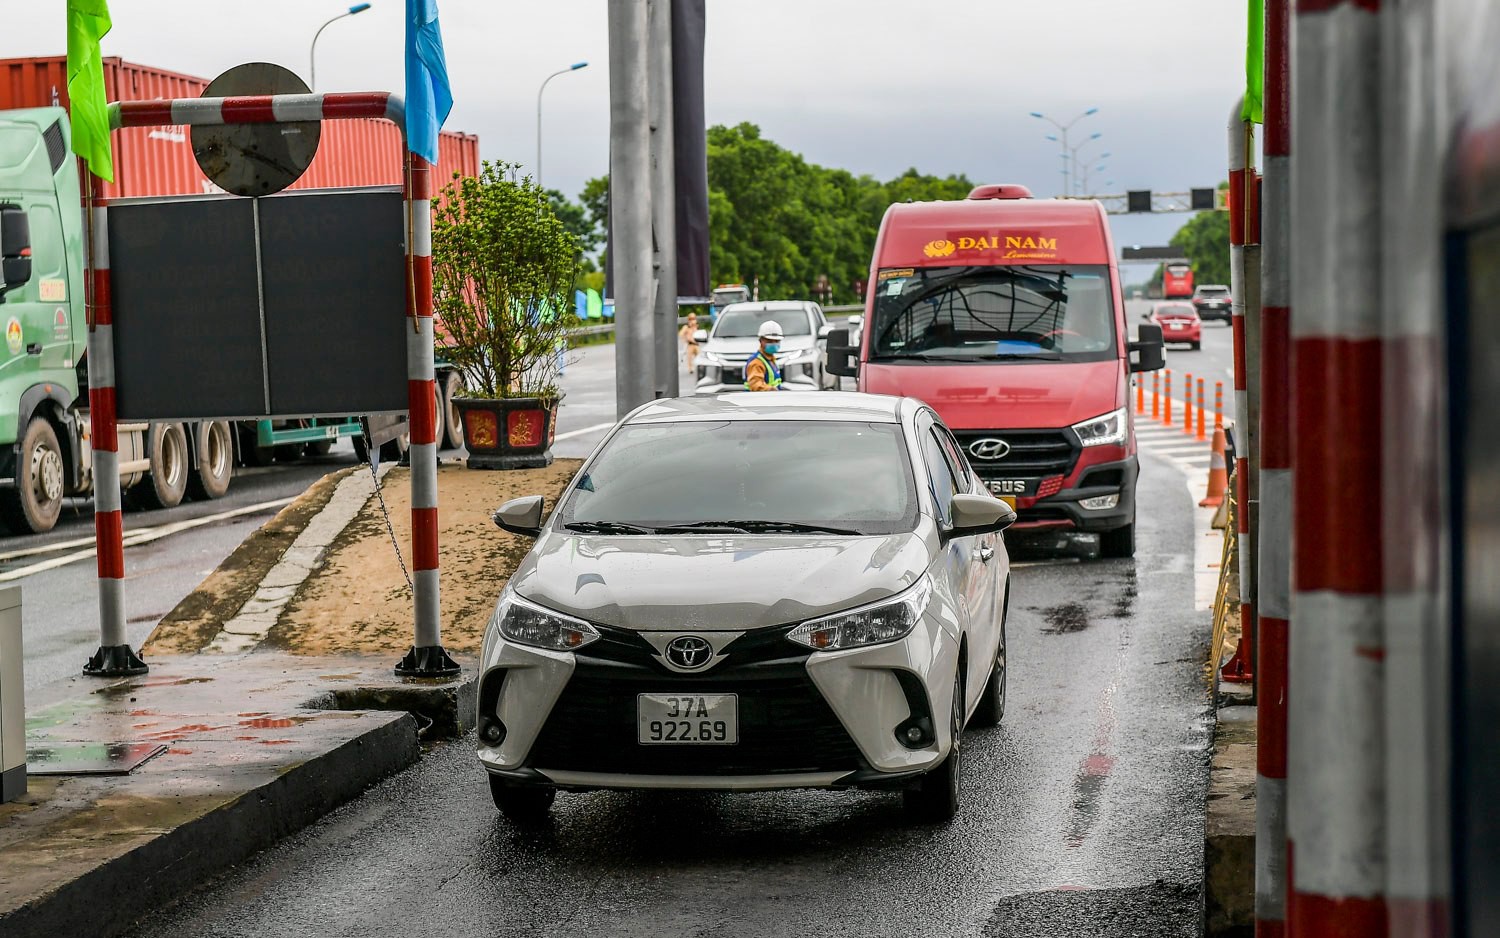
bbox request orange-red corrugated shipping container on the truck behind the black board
[0,56,479,198]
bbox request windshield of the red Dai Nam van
[870,264,1116,363]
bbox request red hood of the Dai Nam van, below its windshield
[860,360,1125,429]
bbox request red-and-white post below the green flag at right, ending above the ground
[1220,101,1259,684]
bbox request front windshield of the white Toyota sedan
[558,420,917,534]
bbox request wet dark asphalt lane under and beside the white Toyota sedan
[123,453,1208,938]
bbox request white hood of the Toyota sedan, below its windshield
[510,525,933,632]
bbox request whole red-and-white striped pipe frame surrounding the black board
[87,92,459,677]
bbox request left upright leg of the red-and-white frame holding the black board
[80,170,149,677]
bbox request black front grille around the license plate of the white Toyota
[527,627,861,776]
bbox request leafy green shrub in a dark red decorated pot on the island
[432,161,579,468]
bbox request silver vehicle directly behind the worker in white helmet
[695,300,839,395]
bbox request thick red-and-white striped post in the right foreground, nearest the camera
[1286,0,1386,938]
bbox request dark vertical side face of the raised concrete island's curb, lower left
[0,714,420,938]
